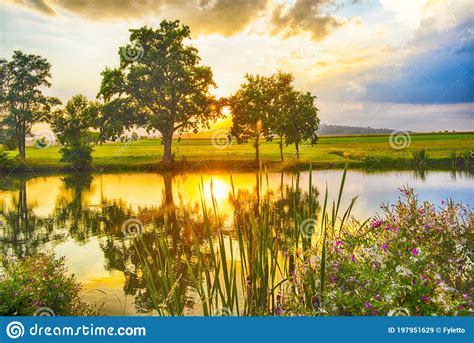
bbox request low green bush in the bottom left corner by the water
[0,254,99,316]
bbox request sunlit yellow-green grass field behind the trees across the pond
[3,132,474,171]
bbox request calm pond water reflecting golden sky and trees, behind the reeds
[0,170,474,315]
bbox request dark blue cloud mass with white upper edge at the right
[367,2,474,104]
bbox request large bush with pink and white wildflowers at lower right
[280,189,474,316]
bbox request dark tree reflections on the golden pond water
[0,173,318,315]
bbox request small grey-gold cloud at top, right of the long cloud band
[271,0,345,40]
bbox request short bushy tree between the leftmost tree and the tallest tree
[50,95,100,170]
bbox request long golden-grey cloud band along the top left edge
[11,0,267,36]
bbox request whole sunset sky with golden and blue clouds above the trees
[0,0,474,131]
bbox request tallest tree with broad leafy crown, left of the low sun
[99,20,219,164]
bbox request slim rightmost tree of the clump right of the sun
[283,92,319,157]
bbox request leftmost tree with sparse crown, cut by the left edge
[0,51,60,161]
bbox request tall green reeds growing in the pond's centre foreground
[135,166,365,316]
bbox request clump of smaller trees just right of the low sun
[227,72,319,161]
